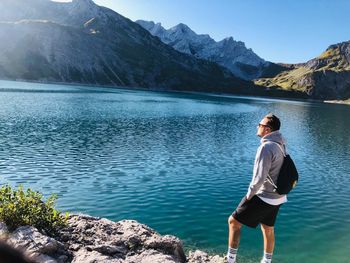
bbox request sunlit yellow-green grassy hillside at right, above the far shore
[255,41,350,100]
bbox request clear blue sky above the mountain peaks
[95,0,350,63]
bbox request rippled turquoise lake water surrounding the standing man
[0,81,350,263]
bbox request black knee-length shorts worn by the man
[232,195,281,228]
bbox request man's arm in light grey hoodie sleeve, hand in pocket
[246,145,272,200]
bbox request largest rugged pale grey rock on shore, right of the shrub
[61,215,186,262]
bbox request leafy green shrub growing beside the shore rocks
[0,185,68,235]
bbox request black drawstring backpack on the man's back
[268,143,299,195]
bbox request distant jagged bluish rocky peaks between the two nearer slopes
[136,20,285,80]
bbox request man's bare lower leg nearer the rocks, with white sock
[227,218,242,263]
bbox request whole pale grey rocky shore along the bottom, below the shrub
[0,215,224,263]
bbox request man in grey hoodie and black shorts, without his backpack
[227,113,287,263]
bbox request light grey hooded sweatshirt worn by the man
[246,131,285,199]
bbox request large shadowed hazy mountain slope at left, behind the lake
[0,0,258,94]
